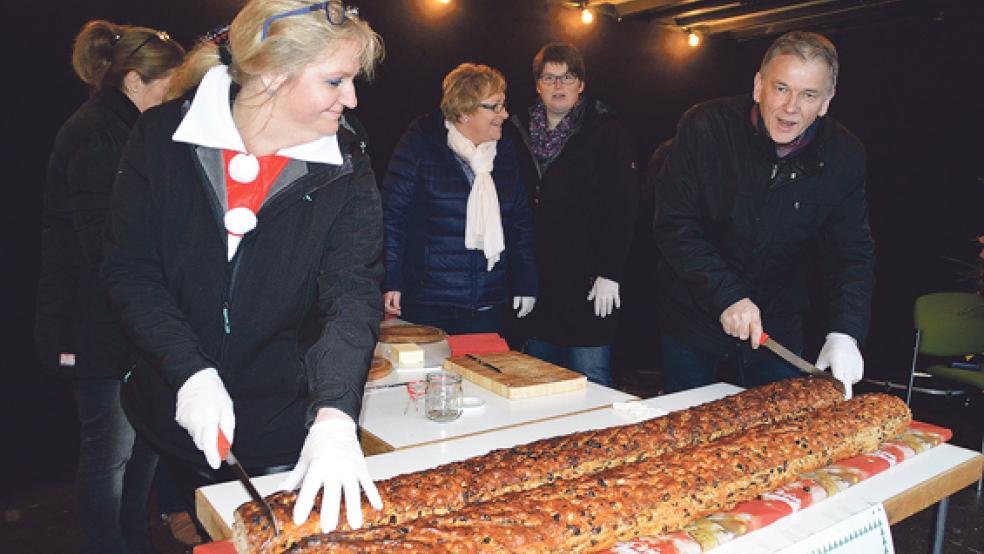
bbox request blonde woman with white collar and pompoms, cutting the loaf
[105,0,382,532]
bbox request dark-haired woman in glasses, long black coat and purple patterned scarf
[512,42,639,387]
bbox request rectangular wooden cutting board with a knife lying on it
[444,351,588,399]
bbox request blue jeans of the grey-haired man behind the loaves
[660,333,803,393]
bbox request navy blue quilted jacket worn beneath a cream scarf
[383,111,538,309]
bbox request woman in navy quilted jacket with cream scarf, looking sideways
[383,64,537,334]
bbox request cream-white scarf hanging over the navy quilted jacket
[444,120,506,271]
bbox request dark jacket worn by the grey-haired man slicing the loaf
[654,95,874,354]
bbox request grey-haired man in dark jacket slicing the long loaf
[654,32,874,396]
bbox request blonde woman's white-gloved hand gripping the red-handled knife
[174,367,236,469]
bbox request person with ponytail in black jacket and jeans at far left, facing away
[35,20,185,553]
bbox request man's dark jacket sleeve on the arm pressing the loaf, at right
[819,148,875,343]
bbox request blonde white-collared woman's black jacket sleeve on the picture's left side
[103,115,217,391]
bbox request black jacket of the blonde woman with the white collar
[105,100,383,467]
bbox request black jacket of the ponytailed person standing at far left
[35,89,140,379]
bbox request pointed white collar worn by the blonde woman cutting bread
[171,64,342,165]
